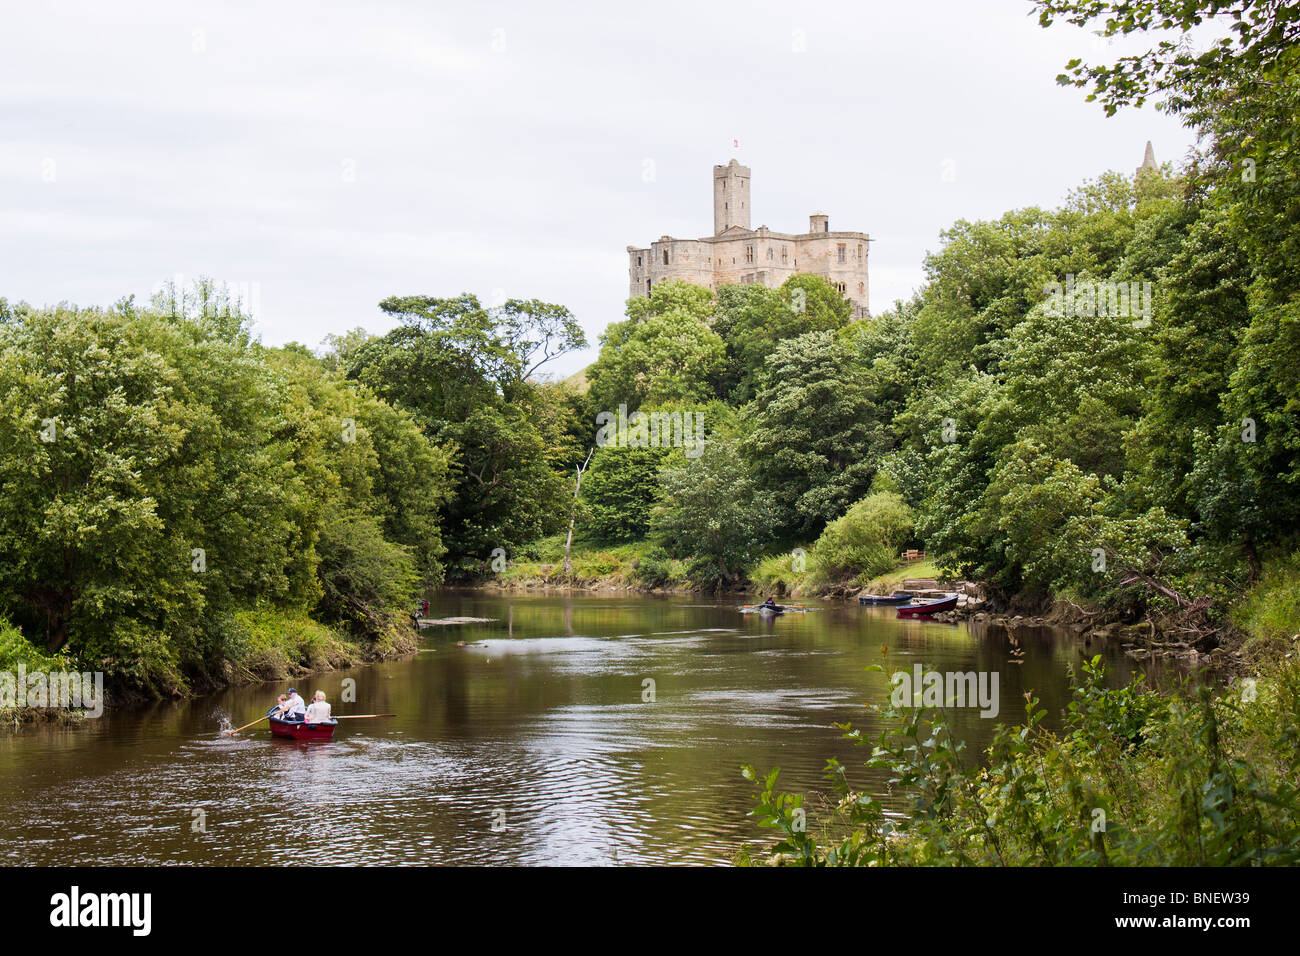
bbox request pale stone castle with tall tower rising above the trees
[628,160,871,319]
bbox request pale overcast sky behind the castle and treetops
[0,0,1192,373]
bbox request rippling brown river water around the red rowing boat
[0,592,1159,866]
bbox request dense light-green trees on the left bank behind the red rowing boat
[0,281,447,695]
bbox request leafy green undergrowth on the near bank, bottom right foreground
[744,657,1300,866]
